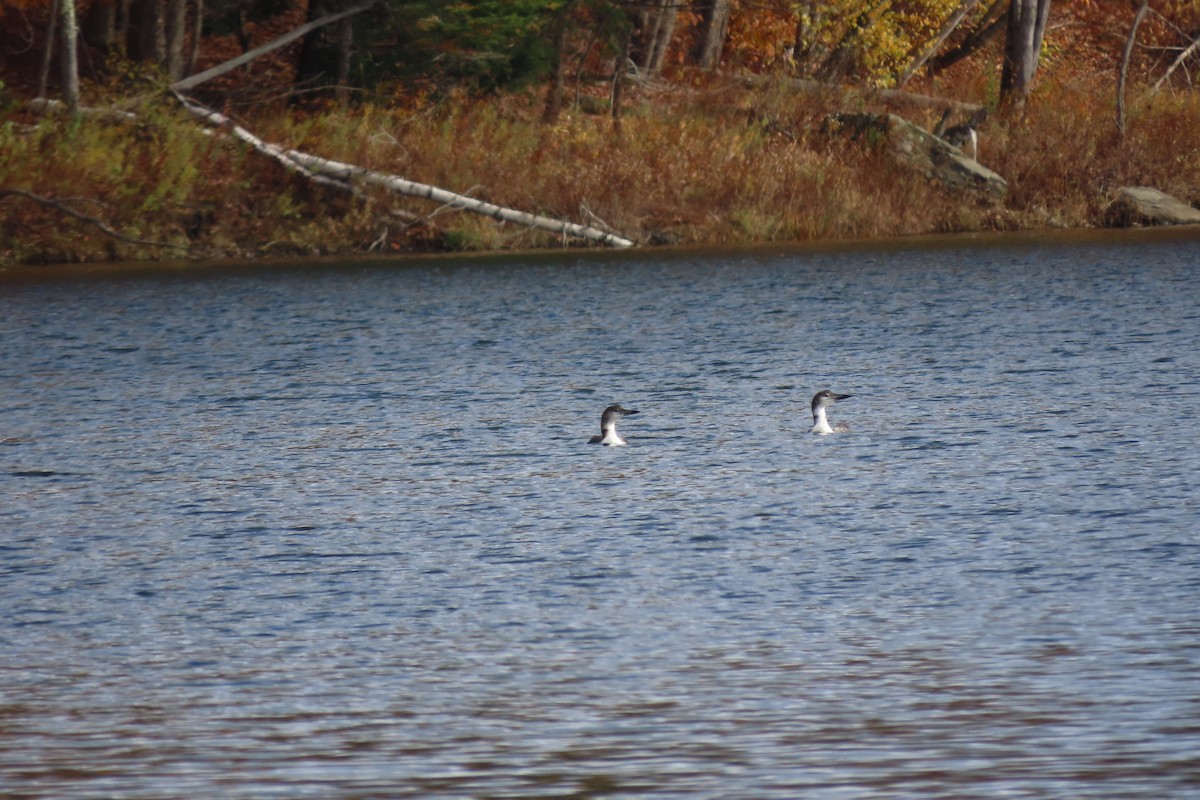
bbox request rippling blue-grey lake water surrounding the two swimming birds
[0,231,1200,799]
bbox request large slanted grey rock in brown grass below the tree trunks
[824,114,1008,201]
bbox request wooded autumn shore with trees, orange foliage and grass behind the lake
[0,0,1200,260]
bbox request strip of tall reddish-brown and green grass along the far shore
[0,76,1200,263]
